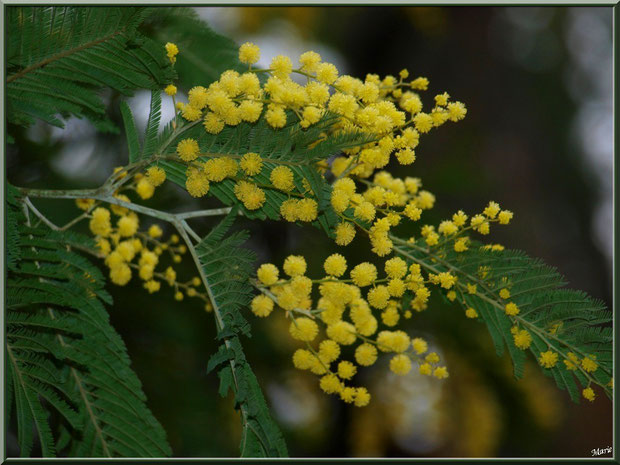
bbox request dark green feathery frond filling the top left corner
[6,6,175,131]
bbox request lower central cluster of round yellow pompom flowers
[251,254,455,407]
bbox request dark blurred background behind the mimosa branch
[7,7,613,457]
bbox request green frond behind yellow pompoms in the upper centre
[160,114,368,236]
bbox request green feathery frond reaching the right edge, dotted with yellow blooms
[395,237,612,401]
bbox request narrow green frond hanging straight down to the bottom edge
[196,211,287,457]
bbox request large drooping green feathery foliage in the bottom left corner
[5,184,171,457]
